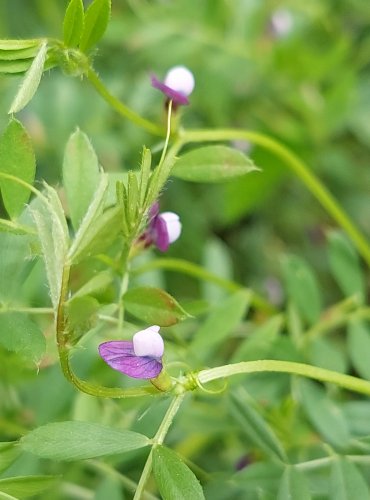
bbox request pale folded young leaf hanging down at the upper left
[9,41,48,114]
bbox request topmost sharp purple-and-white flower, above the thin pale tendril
[152,66,195,106]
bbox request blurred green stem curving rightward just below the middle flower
[132,258,277,313]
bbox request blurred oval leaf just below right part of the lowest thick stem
[296,379,351,448]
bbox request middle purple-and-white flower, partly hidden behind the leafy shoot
[140,202,181,252]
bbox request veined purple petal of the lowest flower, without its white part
[99,340,162,379]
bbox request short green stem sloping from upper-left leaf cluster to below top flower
[86,68,166,136]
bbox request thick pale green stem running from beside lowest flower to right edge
[197,359,370,396]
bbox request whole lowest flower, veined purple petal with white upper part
[99,325,164,379]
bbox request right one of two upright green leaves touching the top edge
[80,0,111,52]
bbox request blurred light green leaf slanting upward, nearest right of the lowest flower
[190,290,250,361]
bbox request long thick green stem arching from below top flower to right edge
[180,129,370,266]
